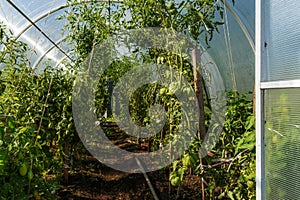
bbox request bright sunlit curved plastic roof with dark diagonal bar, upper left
[0,0,70,67]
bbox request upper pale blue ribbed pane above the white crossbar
[262,0,300,81]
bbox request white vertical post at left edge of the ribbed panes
[255,0,265,200]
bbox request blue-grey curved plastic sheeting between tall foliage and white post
[208,0,255,93]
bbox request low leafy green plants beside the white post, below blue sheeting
[169,91,256,199]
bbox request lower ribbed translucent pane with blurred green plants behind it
[265,88,300,200]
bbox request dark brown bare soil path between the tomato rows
[58,122,201,200]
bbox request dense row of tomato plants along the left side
[0,23,79,199]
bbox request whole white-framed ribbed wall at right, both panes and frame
[256,0,300,200]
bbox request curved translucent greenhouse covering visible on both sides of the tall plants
[0,0,255,92]
